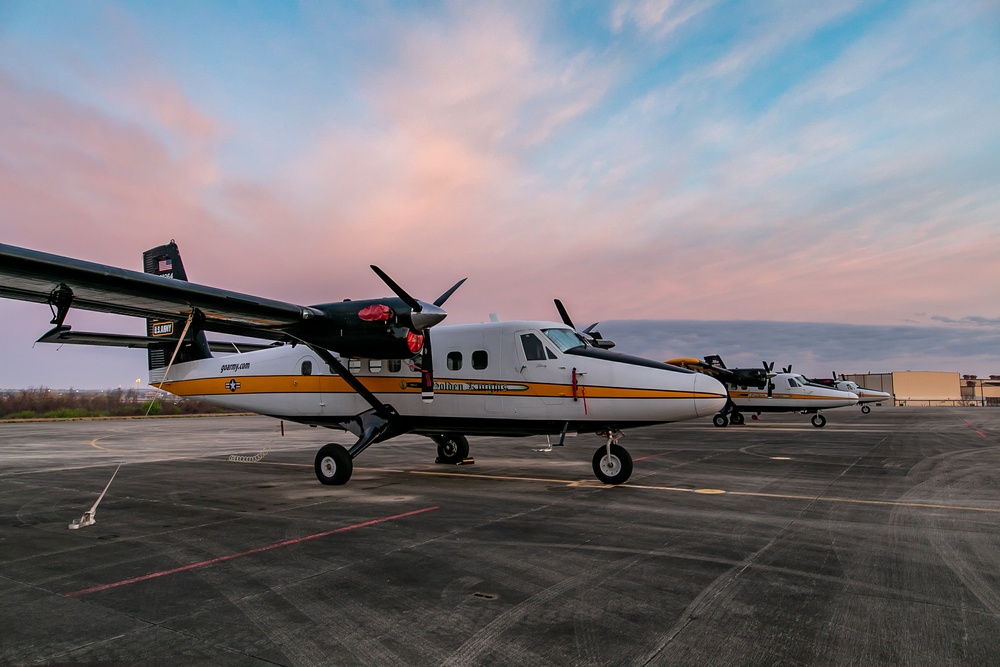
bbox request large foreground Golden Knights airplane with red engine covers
[0,241,727,484]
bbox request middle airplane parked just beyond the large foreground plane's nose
[666,355,858,428]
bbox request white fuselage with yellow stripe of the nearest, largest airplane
[154,321,726,435]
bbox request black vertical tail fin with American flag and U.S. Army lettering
[142,240,212,384]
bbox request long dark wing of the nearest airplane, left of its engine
[0,244,322,339]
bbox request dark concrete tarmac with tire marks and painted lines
[0,407,1000,666]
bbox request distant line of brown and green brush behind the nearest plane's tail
[0,387,235,419]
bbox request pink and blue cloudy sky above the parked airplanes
[0,0,1000,388]
